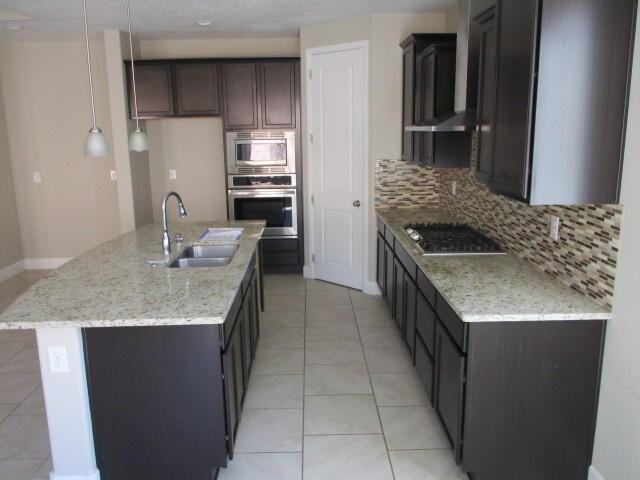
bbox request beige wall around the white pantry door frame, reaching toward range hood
[300,12,455,283]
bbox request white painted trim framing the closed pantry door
[302,40,371,291]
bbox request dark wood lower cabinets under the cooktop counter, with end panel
[377,217,606,480]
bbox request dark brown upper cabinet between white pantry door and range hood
[400,34,471,168]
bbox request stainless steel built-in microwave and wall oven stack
[225,131,298,237]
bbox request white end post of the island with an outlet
[36,328,100,480]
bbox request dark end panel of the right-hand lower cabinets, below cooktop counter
[462,320,606,480]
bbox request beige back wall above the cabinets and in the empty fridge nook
[140,38,300,222]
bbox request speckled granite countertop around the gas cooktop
[376,208,611,322]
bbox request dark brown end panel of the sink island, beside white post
[83,325,227,480]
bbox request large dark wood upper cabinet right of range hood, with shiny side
[471,0,635,205]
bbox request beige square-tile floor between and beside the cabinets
[0,272,466,480]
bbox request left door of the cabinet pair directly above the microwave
[222,62,258,129]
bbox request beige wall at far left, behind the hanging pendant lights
[0,41,120,258]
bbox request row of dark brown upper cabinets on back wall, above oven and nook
[126,58,300,130]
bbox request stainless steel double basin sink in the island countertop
[169,228,243,268]
